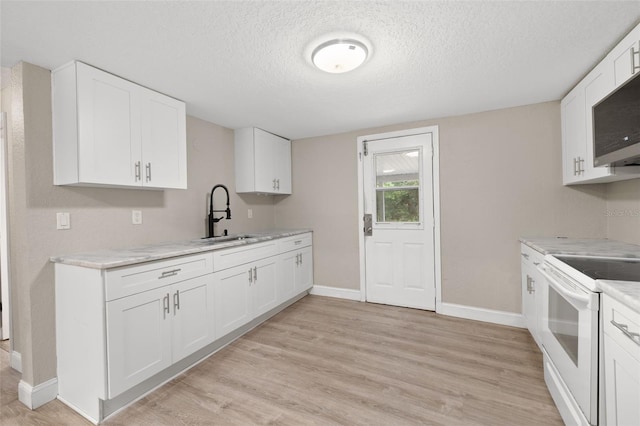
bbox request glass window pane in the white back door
[375,149,420,223]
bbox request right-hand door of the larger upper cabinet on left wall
[140,88,187,189]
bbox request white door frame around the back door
[356,125,442,312]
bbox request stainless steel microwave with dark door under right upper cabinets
[593,72,640,166]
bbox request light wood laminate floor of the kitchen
[0,296,562,426]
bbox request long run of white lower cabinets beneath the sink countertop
[55,233,313,423]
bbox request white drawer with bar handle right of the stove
[602,294,640,362]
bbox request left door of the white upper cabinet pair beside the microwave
[561,86,586,185]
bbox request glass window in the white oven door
[549,286,579,367]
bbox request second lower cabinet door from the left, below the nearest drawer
[170,274,215,363]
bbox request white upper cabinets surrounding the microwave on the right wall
[560,25,640,185]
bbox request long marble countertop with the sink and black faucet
[49,229,312,269]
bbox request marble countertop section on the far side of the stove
[520,237,640,258]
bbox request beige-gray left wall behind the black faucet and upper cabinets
[9,63,274,385]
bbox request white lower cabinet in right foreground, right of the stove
[602,294,640,426]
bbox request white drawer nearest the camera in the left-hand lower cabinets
[105,253,213,301]
